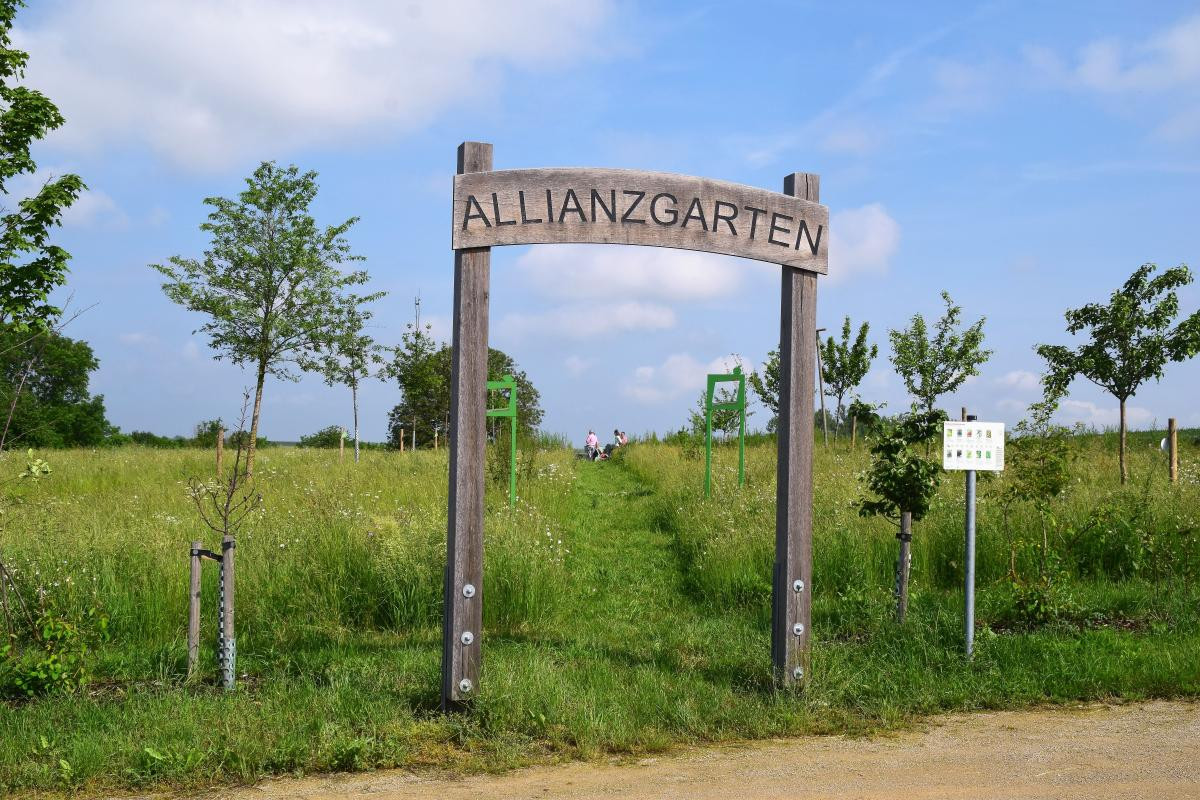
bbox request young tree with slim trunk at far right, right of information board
[1034,264,1200,483]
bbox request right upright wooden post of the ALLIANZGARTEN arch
[770,173,820,686]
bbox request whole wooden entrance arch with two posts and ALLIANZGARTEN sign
[442,142,829,709]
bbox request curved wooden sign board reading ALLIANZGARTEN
[451,168,829,275]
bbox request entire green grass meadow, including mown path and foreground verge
[0,440,1200,795]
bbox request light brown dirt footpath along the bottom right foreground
[201,703,1200,800]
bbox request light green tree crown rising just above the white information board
[888,291,991,411]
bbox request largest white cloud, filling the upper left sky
[13,0,608,168]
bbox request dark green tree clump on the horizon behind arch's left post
[384,324,544,447]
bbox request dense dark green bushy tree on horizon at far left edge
[0,325,112,449]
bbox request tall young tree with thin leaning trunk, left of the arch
[151,162,382,474]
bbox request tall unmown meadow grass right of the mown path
[626,435,1200,615]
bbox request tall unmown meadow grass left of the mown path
[0,447,574,679]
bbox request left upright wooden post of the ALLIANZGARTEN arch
[446,142,492,710]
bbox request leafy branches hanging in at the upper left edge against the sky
[0,0,85,330]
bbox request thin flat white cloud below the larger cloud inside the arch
[497,302,676,339]
